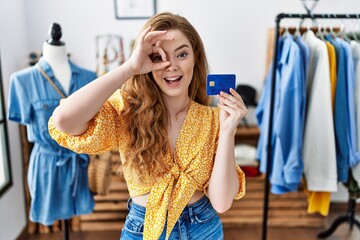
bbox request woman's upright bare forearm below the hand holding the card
[208,129,239,213]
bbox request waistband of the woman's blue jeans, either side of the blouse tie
[127,195,211,218]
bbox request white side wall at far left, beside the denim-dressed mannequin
[0,0,28,239]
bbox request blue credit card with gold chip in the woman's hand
[206,74,236,95]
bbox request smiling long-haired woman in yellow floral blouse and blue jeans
[49,13,247,239]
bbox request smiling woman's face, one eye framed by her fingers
[152,29,195,97]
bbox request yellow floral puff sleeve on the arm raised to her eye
[49,91,127,154]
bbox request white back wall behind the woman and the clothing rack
[21,0,360,90]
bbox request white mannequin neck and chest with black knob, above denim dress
[43,23,71,94]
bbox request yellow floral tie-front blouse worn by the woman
[49,90,245,239]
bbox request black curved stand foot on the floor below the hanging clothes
[318,196,360,238]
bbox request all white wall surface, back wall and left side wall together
[0,0,360,239]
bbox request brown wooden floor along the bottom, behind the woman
[18,205,360,240]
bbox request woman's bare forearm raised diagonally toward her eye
[52,62,134,135]
